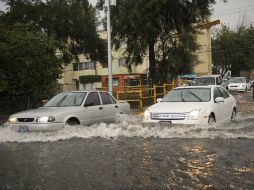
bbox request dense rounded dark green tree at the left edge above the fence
[0,23,62,95]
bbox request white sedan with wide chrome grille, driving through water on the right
[143,85,236,125]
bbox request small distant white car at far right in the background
[228,77,251,91]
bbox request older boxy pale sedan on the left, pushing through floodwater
[5,91,130,131]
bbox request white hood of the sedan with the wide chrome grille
[148,102,209,113]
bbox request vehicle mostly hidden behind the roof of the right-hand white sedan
[193,75,222,86]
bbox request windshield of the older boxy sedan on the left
[44,92,86,107]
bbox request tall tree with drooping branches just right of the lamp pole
[99,0,214,82]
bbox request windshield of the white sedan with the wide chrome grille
[161,88,211,102]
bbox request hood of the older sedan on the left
[11,107,75,118]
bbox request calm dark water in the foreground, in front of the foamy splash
[0,138,254,190]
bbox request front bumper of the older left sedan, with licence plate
[4,123,64,131]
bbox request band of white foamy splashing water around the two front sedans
[0,115,254,143]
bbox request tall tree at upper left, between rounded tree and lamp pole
[0,0,107,63]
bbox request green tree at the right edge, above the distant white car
[212,26,254,76]
